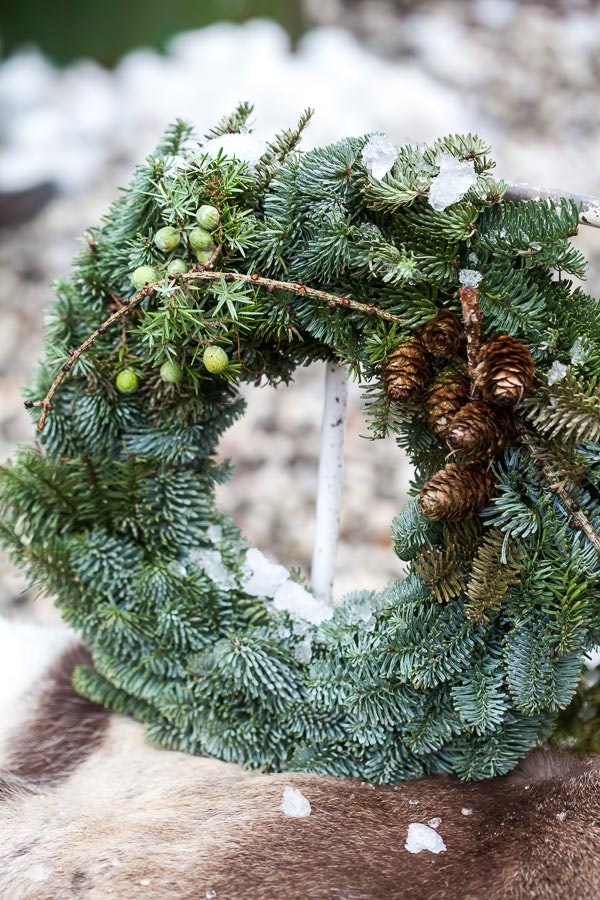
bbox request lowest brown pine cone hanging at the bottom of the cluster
[419,463,494,522]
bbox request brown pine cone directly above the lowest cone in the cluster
[445,400,516,462]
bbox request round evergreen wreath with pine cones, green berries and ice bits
[0,104,600,782]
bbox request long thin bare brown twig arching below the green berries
[25,268,403,431]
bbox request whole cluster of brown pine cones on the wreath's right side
[381,309,534,522]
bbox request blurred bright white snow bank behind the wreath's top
[0,20,472,190]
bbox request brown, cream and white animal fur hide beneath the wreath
[0,620,600,900]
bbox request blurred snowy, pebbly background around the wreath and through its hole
[0,0,600,620]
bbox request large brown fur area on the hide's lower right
[210,752,600,900]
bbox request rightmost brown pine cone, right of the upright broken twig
[475,334,534,409]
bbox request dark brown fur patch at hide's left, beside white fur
[7,645,110,782]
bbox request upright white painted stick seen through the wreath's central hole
[310,363,348,603]
